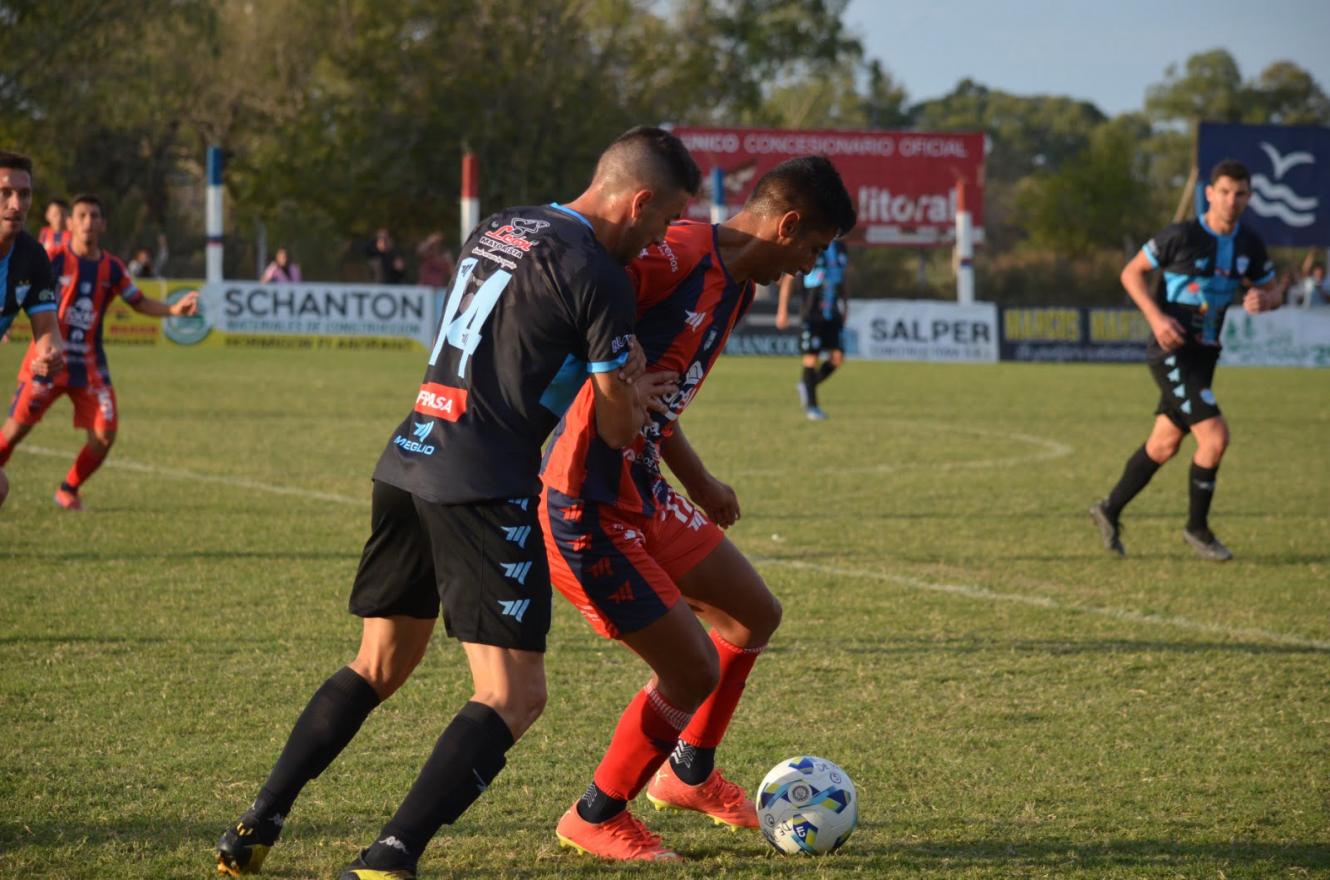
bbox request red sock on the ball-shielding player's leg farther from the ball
[596,685,688,800]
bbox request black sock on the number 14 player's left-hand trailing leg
[253,666,379,819]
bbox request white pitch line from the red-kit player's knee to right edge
[749,556,1330,651]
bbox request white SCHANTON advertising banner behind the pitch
[194,280,435,348]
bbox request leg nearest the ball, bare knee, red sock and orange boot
[646,540,781,828]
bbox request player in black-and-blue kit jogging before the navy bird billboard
[1089,160,1283,562]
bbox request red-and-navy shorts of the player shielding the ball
[540,488,725,638]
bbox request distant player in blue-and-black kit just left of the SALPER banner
[775,233,850,421]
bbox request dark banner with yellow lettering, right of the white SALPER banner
[1000,306,1150,363]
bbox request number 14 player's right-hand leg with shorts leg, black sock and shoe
[342,498,552,880]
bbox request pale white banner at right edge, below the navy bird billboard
[1220,307,1330,367]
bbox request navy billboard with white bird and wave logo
[1196,122,1330,246]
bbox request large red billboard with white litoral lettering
[674,126,984,247]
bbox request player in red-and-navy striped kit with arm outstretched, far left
[0,195,198,510]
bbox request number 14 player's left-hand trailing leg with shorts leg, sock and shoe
[217,483,439,876]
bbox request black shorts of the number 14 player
[350,480,552,651]
